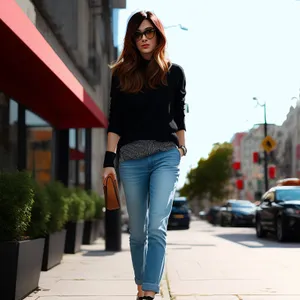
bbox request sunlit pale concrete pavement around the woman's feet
[26,221,300,300]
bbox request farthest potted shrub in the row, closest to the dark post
[79,190,96,245]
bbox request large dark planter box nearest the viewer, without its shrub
[0,239,45,300]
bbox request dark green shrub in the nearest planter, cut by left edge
[0,171,34,242]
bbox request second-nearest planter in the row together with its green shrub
[38,181,68,271]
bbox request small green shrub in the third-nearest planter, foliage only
[63,189,85,222]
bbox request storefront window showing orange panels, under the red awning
[25,110,52,183]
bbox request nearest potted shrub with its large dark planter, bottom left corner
[0,172,45,300]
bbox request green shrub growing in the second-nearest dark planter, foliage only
[45,181,70,234]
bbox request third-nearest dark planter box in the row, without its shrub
[65,221,84,254]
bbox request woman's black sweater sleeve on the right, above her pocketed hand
[174,66,186,131]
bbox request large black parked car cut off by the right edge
[256,186,300,242]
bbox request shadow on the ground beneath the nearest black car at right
[215,233,300,248]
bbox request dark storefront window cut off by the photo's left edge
[0,92,18,171]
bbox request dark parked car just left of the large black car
[220,200,257,226]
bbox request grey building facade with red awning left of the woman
[0,0,126,194]
